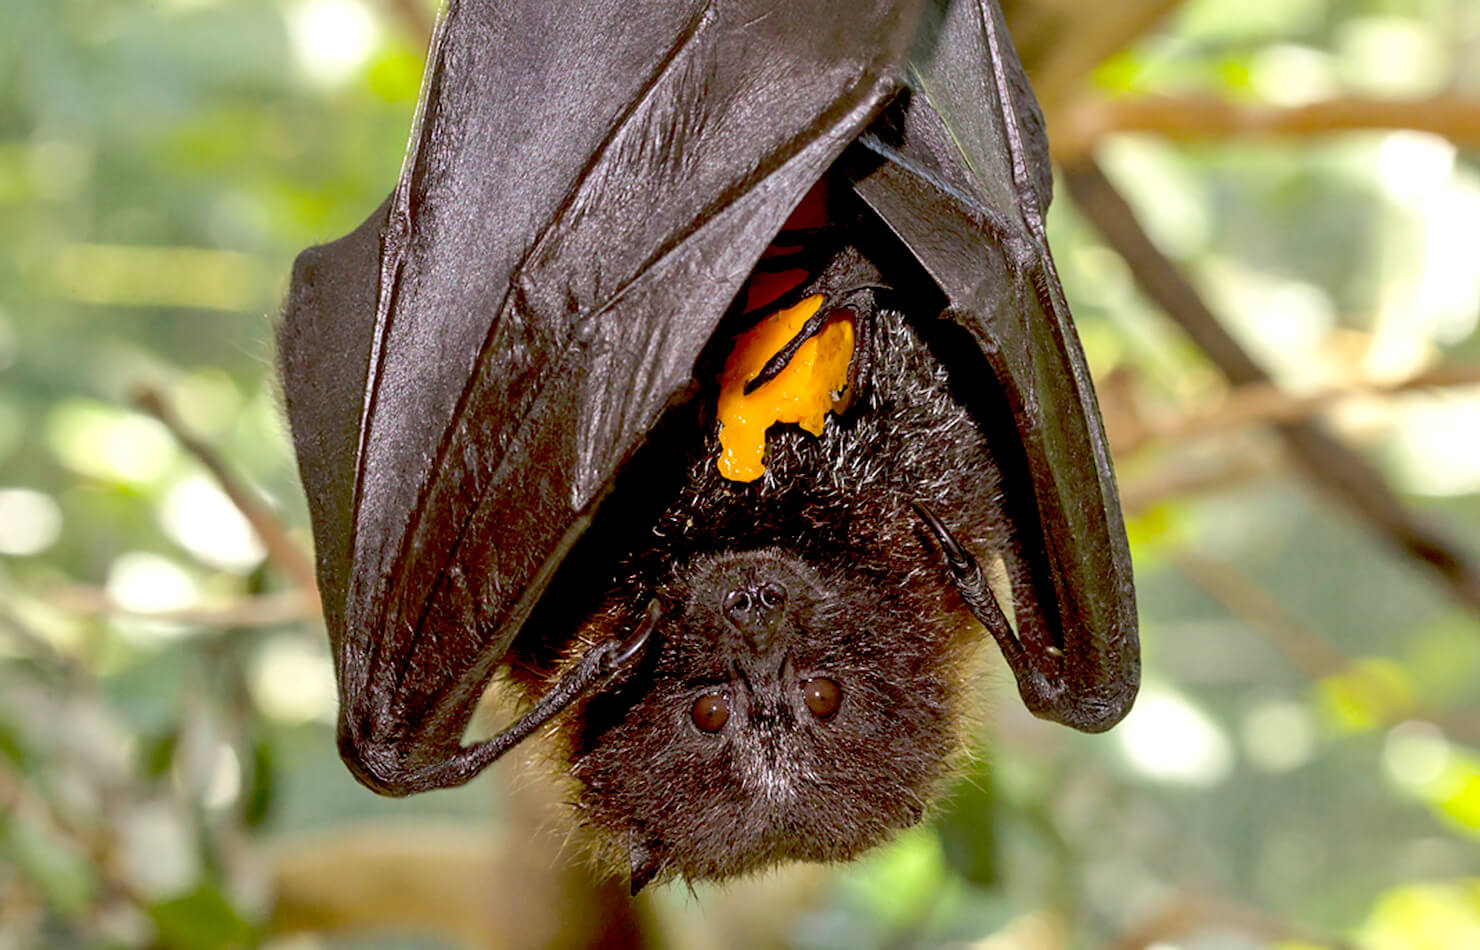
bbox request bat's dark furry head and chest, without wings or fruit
[514,245,1005,889]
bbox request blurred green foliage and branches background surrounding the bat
[0,0,1480,950]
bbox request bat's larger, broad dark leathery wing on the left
[281,0,918,793]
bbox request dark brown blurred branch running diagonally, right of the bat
[1064,160,1480,614]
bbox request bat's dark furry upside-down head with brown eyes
[570,538,968,889]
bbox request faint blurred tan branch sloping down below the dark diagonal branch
[1175,550,1480,746]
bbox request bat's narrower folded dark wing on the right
[852,0,1140,731]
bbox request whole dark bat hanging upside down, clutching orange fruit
[278,0,1140,894]
